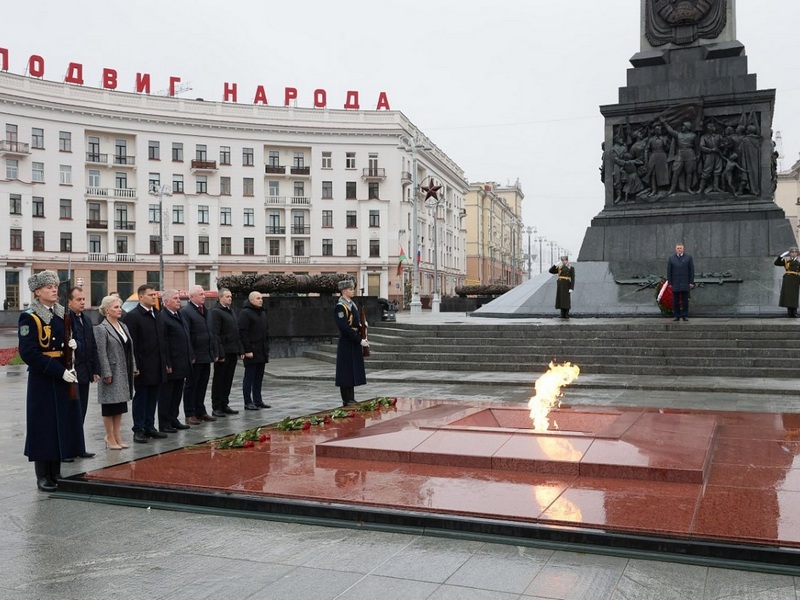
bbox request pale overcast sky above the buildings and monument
[0,0,800,255]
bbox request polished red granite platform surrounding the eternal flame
[79,399,800,548]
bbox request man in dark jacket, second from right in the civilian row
[209,288,244,417]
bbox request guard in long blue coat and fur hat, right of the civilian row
[333,279,369,406]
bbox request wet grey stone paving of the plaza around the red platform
[0,314,800,600]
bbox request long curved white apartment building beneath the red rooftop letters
[0,73,467,308]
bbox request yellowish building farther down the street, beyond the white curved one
[466,181,526,286]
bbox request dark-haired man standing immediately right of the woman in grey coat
[124,283,167,444]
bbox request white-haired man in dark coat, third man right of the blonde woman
[180,285,217,425]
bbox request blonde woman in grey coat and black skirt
[94,296,138,450]
